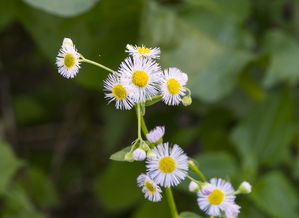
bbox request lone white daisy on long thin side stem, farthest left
[56,38,80,79]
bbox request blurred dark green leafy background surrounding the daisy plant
[0,0,299,218]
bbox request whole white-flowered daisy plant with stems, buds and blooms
[56,38,251,218]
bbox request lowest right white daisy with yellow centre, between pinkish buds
[197,178,236,216]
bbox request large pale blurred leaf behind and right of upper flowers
[141,2,253,101]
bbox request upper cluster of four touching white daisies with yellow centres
[104,45,188,110]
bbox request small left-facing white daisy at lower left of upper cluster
[104,74,134,110]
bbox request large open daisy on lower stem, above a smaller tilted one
[146,143,188,187]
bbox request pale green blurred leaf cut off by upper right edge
[263,30,299,87]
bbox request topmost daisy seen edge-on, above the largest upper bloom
[126,44,160,59]
